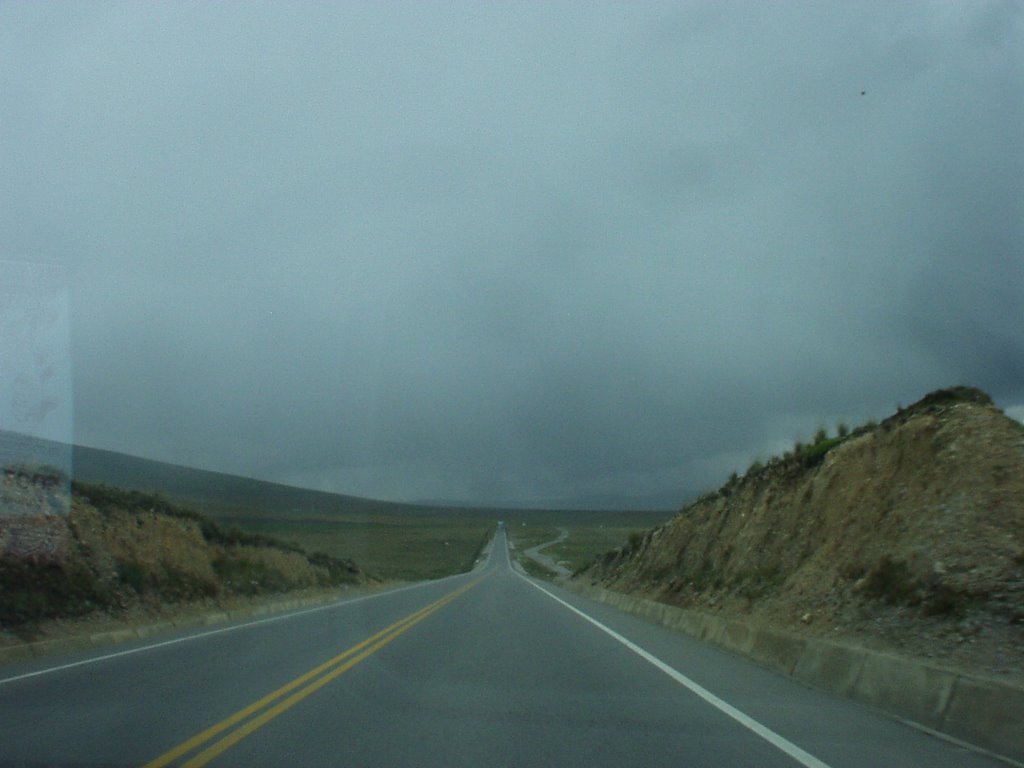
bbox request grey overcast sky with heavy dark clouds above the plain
[0,0,1024,508]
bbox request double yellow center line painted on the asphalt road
[142,579,480,768]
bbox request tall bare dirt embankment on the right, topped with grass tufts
[578,387,1024,683]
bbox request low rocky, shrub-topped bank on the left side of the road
[0,481,366,636]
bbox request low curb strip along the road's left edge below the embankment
[0,589,380,664]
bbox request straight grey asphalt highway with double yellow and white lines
[0,529,1002,768]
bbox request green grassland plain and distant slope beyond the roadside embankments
[9,436,671,581]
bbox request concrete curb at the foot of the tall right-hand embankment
[556,580,1024,761]
